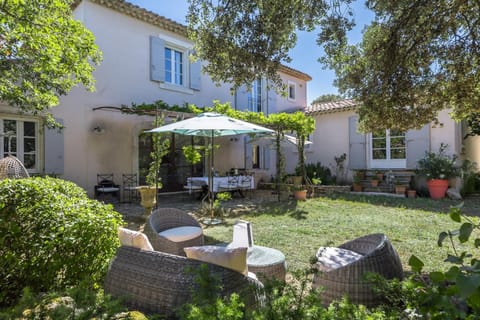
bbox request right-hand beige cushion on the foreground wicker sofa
[183,246,248,275]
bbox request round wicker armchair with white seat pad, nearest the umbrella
[145,208,203,256]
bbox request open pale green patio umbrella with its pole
[147,112,275,212]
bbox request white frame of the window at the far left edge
[0,114,43,174]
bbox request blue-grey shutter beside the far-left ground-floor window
[44,119,65,174]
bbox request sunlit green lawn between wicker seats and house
[204,195,480,271]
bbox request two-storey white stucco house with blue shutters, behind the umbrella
[0,0,311,195]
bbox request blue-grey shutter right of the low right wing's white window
[405,124,430,169]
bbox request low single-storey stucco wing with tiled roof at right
[305,100,479,185]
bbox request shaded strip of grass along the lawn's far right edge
[323,193,480,216]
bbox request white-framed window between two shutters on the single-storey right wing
[369,130,407,168]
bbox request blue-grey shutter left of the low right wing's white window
[348,116,367,170]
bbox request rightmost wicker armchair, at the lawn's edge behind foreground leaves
[312,233,403,306]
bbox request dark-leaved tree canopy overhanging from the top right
[188,0,480,131]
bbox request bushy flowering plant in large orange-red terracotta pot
[417,143,458,199]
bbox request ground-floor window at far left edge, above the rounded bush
[0,117,40,173]
